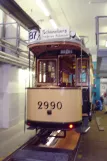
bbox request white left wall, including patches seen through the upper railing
[0,13,28,128]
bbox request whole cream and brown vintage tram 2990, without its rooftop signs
[27,28,93,130]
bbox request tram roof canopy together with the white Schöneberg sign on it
[28,28,89,56]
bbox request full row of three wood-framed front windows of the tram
[37,54,89,87]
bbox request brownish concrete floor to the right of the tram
[76,112,107,161]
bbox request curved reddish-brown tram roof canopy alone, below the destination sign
[28,39,89,56]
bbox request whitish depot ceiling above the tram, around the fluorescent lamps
[15,0,107,64]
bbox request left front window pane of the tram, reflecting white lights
[38,60,57,83]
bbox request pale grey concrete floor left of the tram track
[0,122,35,161]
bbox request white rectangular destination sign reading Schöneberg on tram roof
[40,28,70,40]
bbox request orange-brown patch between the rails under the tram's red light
[55,131,80,150]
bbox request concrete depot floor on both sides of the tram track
[0,111,107,161]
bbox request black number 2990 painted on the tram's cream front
[38,101,62,110]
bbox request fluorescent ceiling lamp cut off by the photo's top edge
[36,0,50,16]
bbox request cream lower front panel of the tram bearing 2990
[27,88,82,129]
